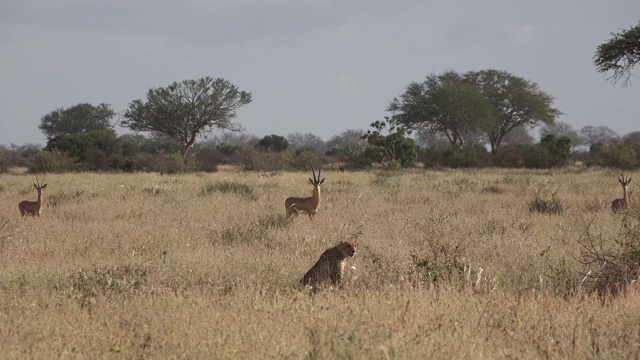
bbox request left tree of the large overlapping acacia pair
[387,71,493,148]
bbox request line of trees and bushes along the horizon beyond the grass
[0,20,640,173]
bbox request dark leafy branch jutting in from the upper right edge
[593,22,640,86]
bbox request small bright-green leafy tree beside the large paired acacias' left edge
[363,116,417,167]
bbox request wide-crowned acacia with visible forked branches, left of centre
[122,77,252,156]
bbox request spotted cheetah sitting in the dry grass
[300,241,358,289]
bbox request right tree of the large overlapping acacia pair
[464,69,562,155]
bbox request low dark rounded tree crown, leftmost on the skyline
[38,103,115,139]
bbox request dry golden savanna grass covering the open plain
[0,169,640,359]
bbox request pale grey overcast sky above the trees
[0,0,640,145]
